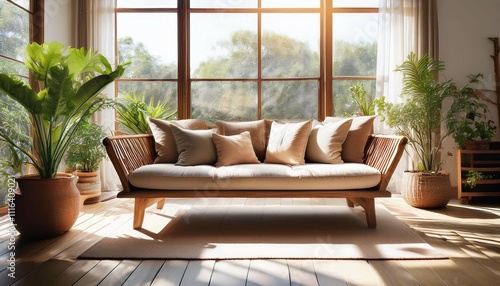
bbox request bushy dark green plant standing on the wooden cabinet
[446,73,496,149]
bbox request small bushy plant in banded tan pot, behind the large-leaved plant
[66,121,109,203]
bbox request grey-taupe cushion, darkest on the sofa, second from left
[170,124,217,166]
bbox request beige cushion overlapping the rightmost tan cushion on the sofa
[306,119,352,164]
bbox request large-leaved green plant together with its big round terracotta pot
[0,41,124,238]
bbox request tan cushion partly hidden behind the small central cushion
[215,120,266,162]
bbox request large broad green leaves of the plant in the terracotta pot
[0,42,125,178]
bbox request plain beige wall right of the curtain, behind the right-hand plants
[438,0,500,186]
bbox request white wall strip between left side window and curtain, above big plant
[45,0,77,46]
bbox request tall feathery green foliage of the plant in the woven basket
[378,53,453,173]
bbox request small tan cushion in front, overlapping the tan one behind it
[212,131,260,167]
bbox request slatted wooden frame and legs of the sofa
[103,135,407,229]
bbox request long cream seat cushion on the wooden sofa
[129,163,381,190]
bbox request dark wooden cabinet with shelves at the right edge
[456,141,500,199]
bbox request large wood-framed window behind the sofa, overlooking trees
[116,0,378,122]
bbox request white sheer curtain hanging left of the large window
[78,0,121,191]
